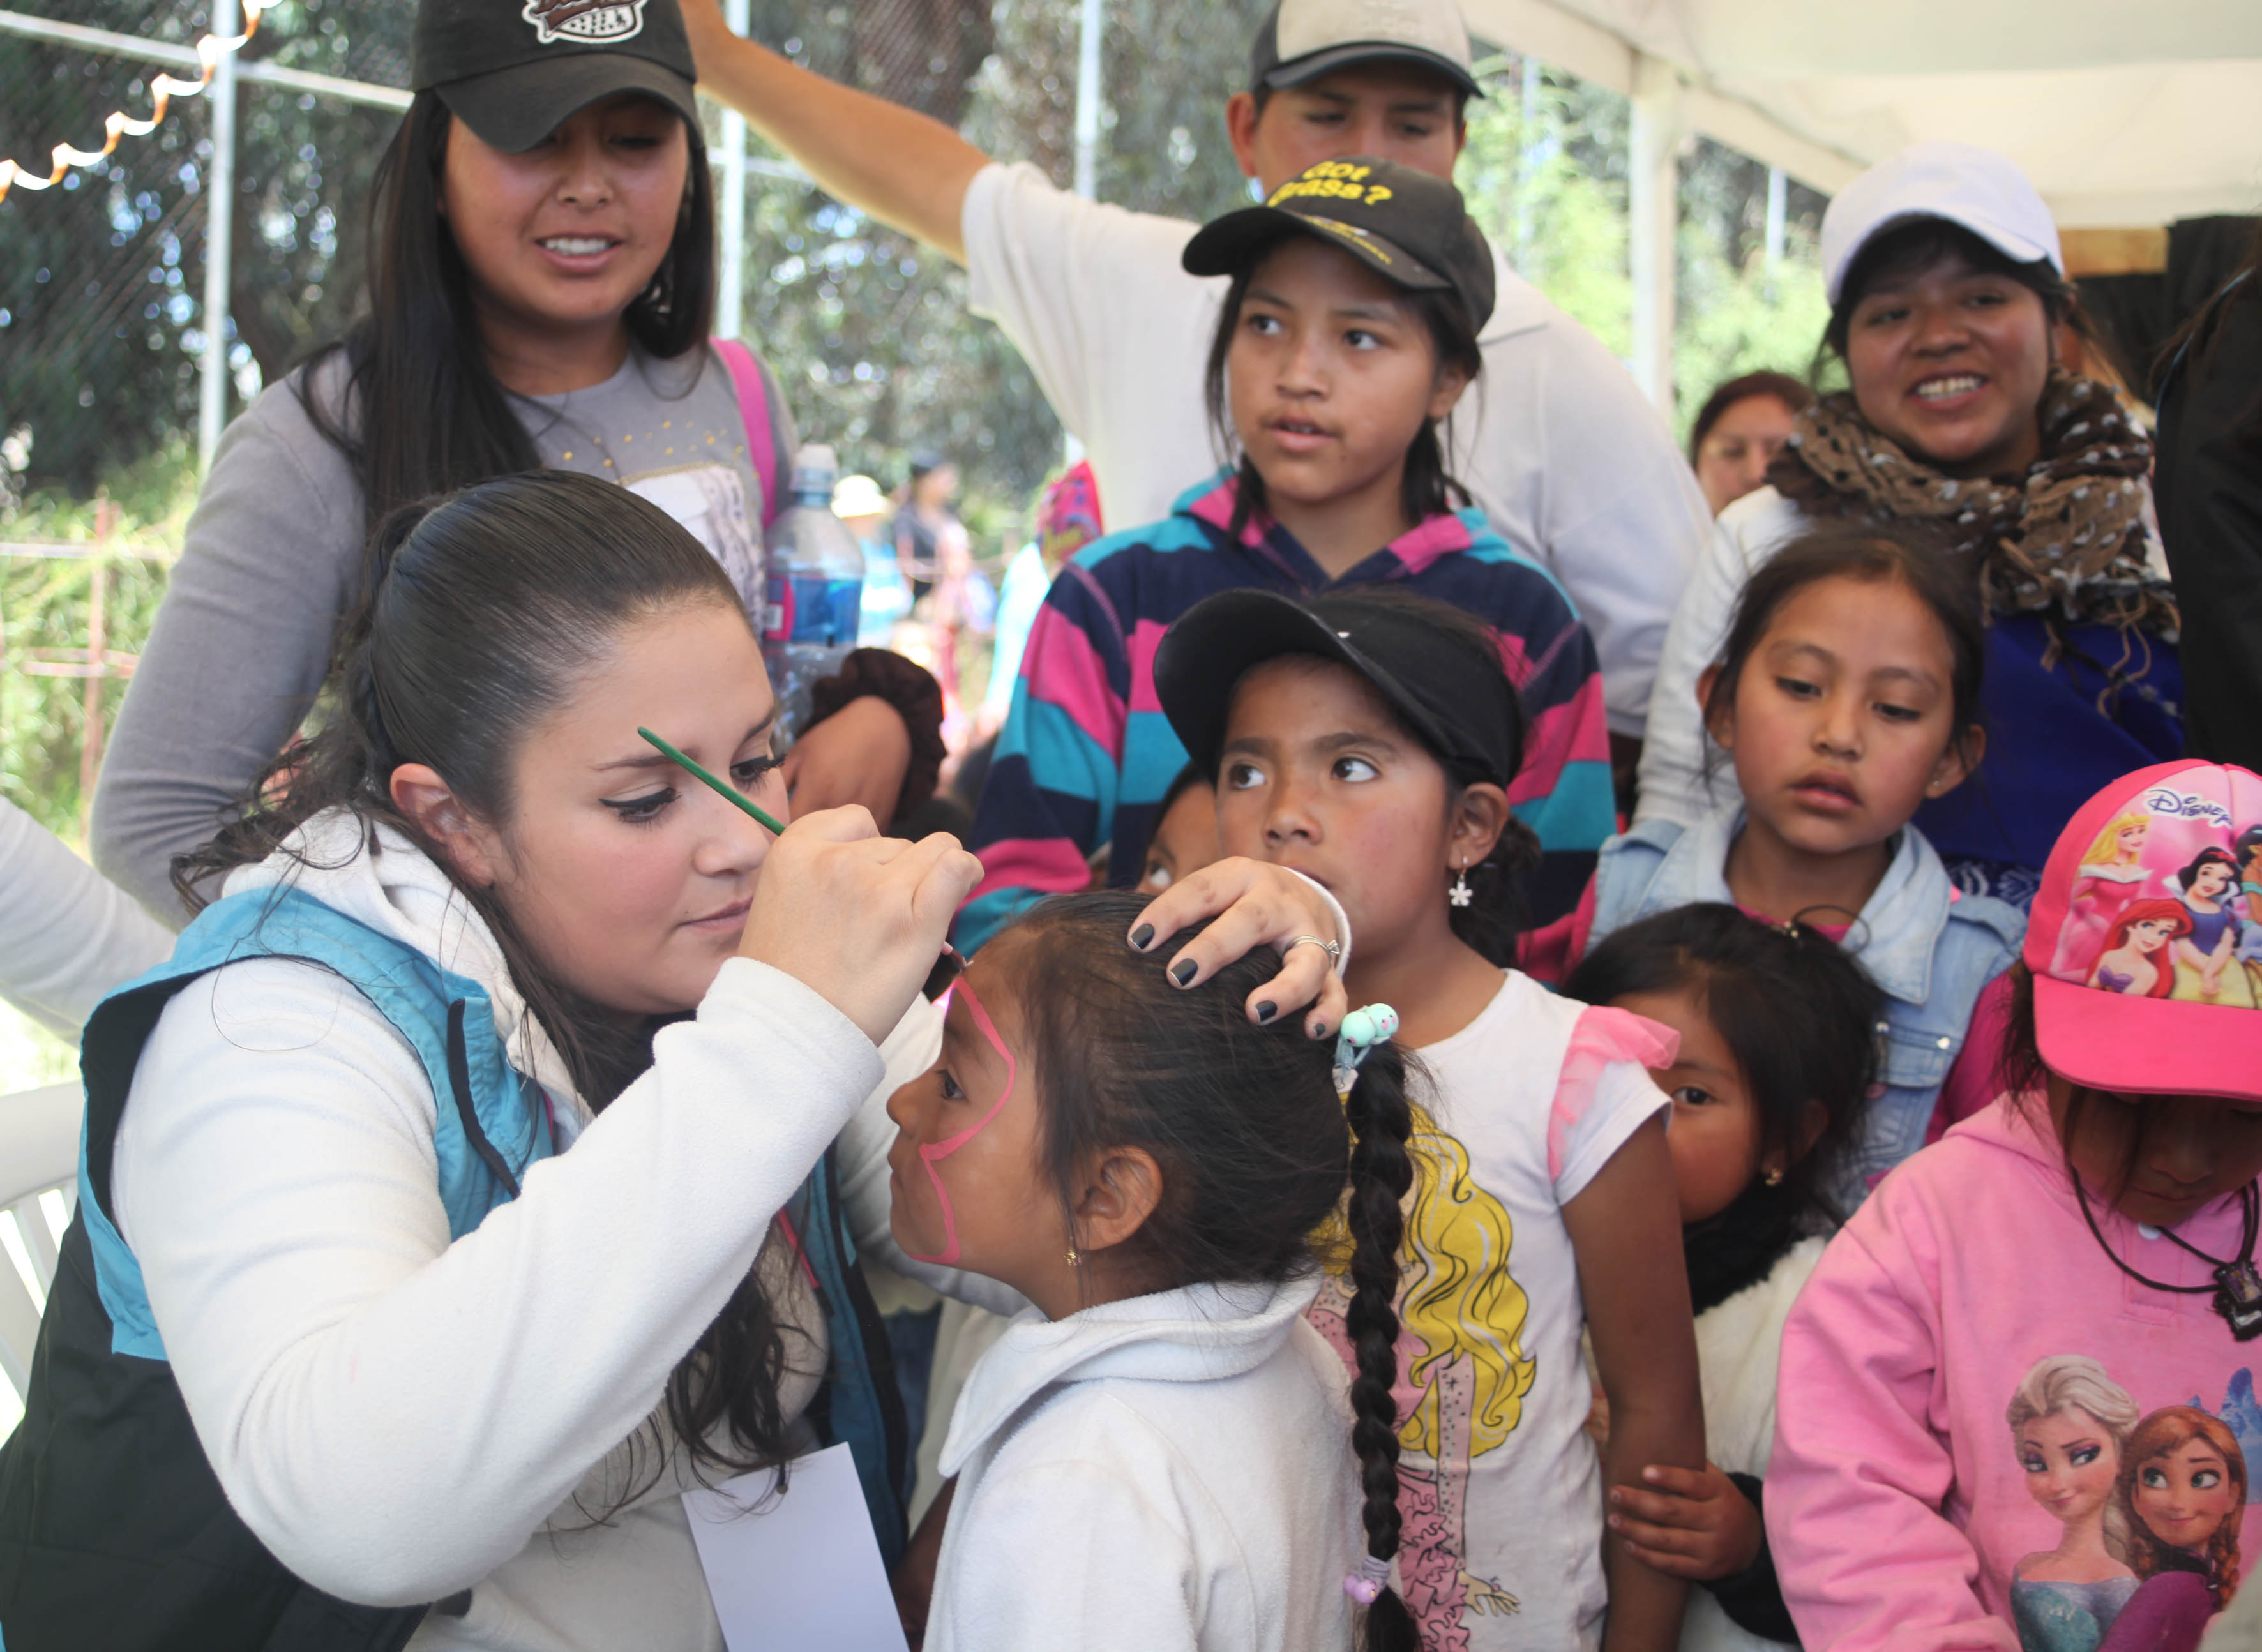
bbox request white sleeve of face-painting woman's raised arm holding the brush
[113,959,880,1605]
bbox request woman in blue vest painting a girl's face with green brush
[0,470,1341,1652]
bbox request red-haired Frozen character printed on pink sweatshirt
[2099,1406,2246,1652]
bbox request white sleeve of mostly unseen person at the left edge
[0,799,172,1041]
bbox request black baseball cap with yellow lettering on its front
[1179,154,1493,333]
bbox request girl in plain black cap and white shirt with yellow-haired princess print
[1156,589,1703,1652]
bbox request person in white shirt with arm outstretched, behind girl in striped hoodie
[683,0,1710,740]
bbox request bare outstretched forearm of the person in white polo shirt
[683,0,988,265]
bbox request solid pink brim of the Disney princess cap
[2033,964,2262,1100]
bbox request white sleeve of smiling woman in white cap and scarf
[1633,489,1800,823]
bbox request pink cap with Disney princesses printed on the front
[2024,760,2262,1097]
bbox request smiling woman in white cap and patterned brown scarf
[1638,142,2183,905]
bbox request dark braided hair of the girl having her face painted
[991,889,1421,1652]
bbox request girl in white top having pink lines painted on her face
[887,894,1421,1652]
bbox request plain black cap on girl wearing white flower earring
[1154,590,1525,788]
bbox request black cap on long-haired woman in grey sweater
[409,0,699,154]
